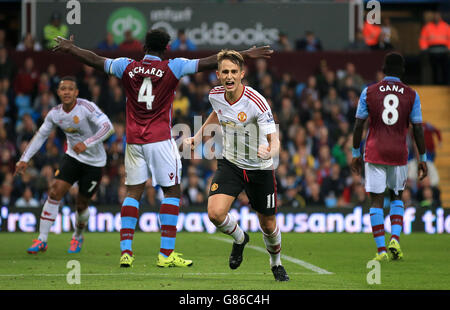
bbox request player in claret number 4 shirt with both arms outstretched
[55,29,273,267]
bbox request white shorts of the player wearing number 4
[125,139,181,187]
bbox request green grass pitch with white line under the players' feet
[0,232,450,290]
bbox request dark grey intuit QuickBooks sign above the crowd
[36,1,352,50]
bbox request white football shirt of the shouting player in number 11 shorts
[209,86,276,170]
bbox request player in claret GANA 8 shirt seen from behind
[351,53,427,261]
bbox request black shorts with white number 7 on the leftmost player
[55,154,102,198]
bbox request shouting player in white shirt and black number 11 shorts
[184,50,289,281]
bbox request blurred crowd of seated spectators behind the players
[0,44,440,210]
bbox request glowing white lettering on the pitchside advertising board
[0,206,450,234]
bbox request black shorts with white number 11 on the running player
[209,159,277,215]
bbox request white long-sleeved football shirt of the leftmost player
[20,98,114,167]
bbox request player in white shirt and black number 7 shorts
[14,77,114,254]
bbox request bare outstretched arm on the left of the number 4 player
[53,35,106,71]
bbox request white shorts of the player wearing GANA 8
[365,163,408,195]
